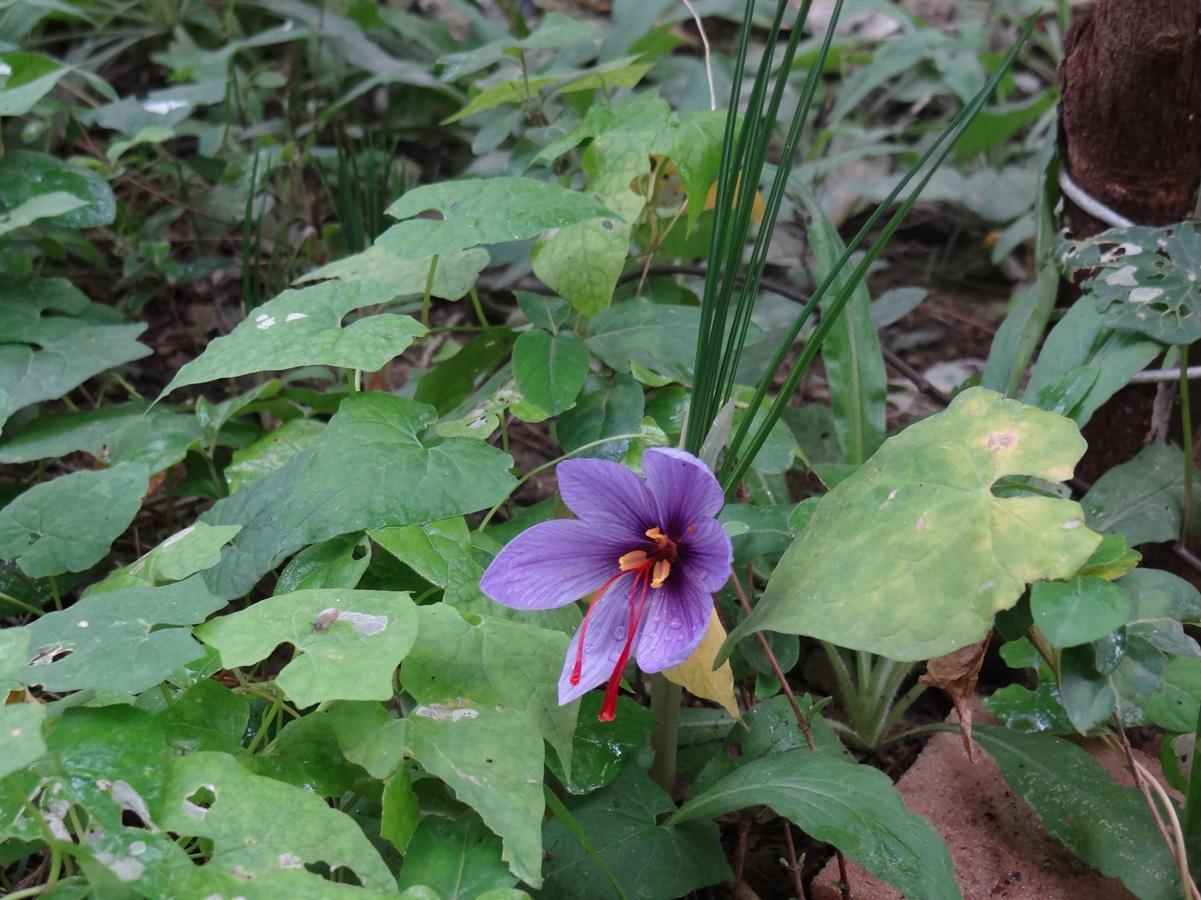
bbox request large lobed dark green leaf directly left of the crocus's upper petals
[203,392,514,596]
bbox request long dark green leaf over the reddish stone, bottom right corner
[972,725,1181,900]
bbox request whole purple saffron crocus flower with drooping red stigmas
[479,448,733,721]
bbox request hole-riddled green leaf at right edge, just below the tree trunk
[1056,222,1201,344]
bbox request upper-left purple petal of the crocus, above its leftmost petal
[555,459,658,533]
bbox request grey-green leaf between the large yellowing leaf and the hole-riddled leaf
[1022,291,1164,425]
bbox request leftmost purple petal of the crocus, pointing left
[479,519,629,609]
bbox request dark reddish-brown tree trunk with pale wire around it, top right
[1059,0,1201,238]
